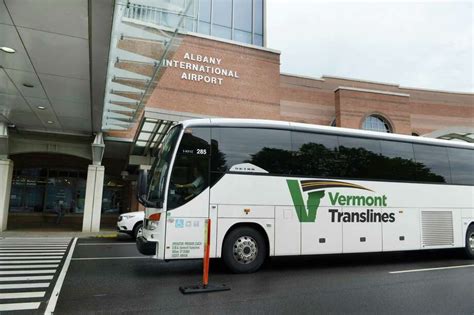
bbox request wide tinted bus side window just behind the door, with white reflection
[212,128,291,174]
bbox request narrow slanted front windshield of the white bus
[148,125,181,206]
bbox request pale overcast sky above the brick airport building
[267,0,474,93]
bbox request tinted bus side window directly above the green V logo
[292,131,339,177]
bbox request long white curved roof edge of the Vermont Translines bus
[181,118,474,149]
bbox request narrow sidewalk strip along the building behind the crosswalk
[0,229,118,239]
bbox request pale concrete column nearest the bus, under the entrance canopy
[82,165,105,232]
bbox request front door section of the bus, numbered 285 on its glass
[165,127,210,259]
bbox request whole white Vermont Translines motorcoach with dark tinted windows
[137,119,474,272]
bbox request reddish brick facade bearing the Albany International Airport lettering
[108,31,474,137]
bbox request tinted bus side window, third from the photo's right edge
[379,141,415,181]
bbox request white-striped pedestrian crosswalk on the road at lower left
[0,238,76,313]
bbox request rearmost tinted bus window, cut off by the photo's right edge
[448,148,474,185]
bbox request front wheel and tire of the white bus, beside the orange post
[222,226,268,273]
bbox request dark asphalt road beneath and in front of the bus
[43,238,474,314]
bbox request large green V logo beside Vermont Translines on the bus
[286,179,325,222]
